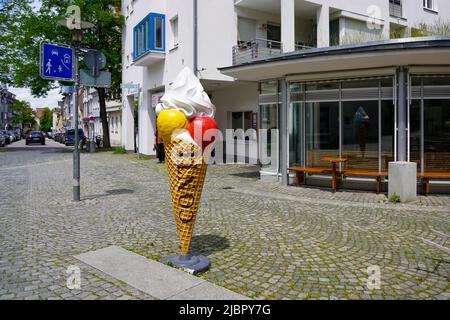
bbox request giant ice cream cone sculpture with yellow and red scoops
[156,68,217,266]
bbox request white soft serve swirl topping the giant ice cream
[155,67,216,119]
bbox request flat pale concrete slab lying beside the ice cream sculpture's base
[75,246,248,300]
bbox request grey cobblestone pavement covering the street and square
[0,141,450,300]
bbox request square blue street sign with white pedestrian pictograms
[40,43,76,81]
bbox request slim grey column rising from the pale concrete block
[398,67,407,161]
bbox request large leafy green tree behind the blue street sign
[0,0,124,148]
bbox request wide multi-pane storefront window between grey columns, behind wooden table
[289,77,395,171]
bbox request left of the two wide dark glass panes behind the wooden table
[306,102,339,167]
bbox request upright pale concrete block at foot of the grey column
[388,162,417,203]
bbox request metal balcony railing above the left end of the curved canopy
[233,38,283,65]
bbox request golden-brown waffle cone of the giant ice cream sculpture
[165,140,208,254]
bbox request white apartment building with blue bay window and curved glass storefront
[122,0,450,192]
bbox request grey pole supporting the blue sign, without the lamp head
[73,41,80,201]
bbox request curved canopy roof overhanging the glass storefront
[219,36,450,81]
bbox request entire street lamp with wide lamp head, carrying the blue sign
[58,18,94,201]
